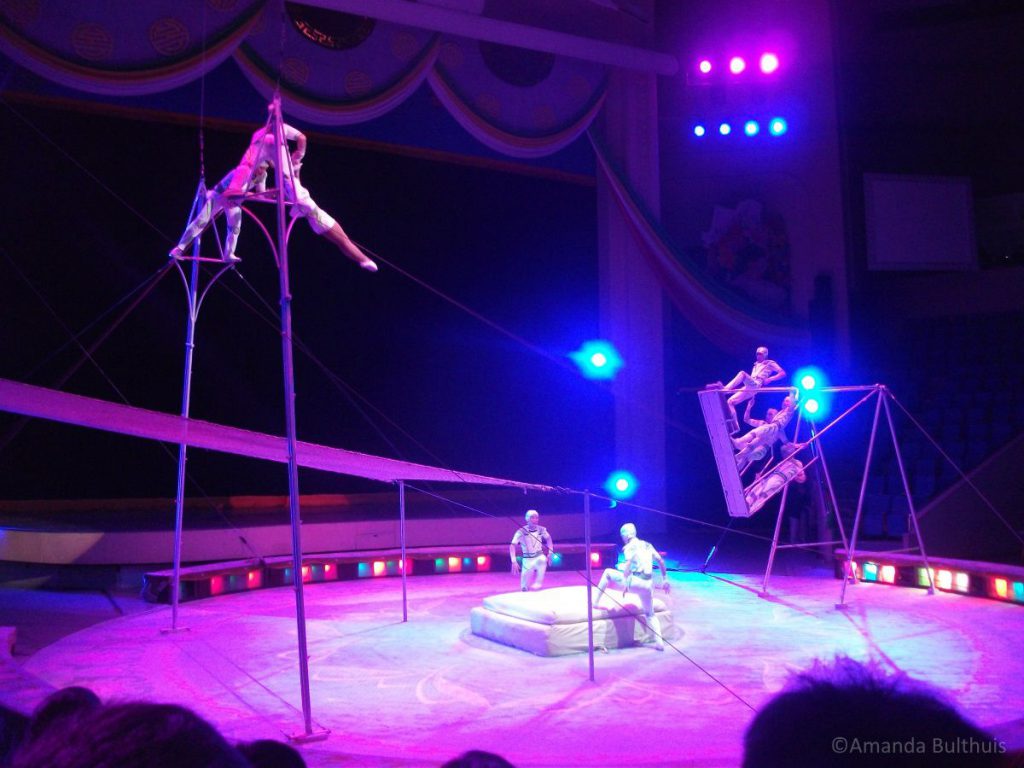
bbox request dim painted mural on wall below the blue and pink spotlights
[694,200,792,315]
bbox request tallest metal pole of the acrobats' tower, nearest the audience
[273,93,313,736]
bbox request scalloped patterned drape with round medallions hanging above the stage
[0,0,606,158]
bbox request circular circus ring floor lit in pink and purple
[8,572,1024,768]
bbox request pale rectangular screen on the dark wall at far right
[864,173,978,270]
